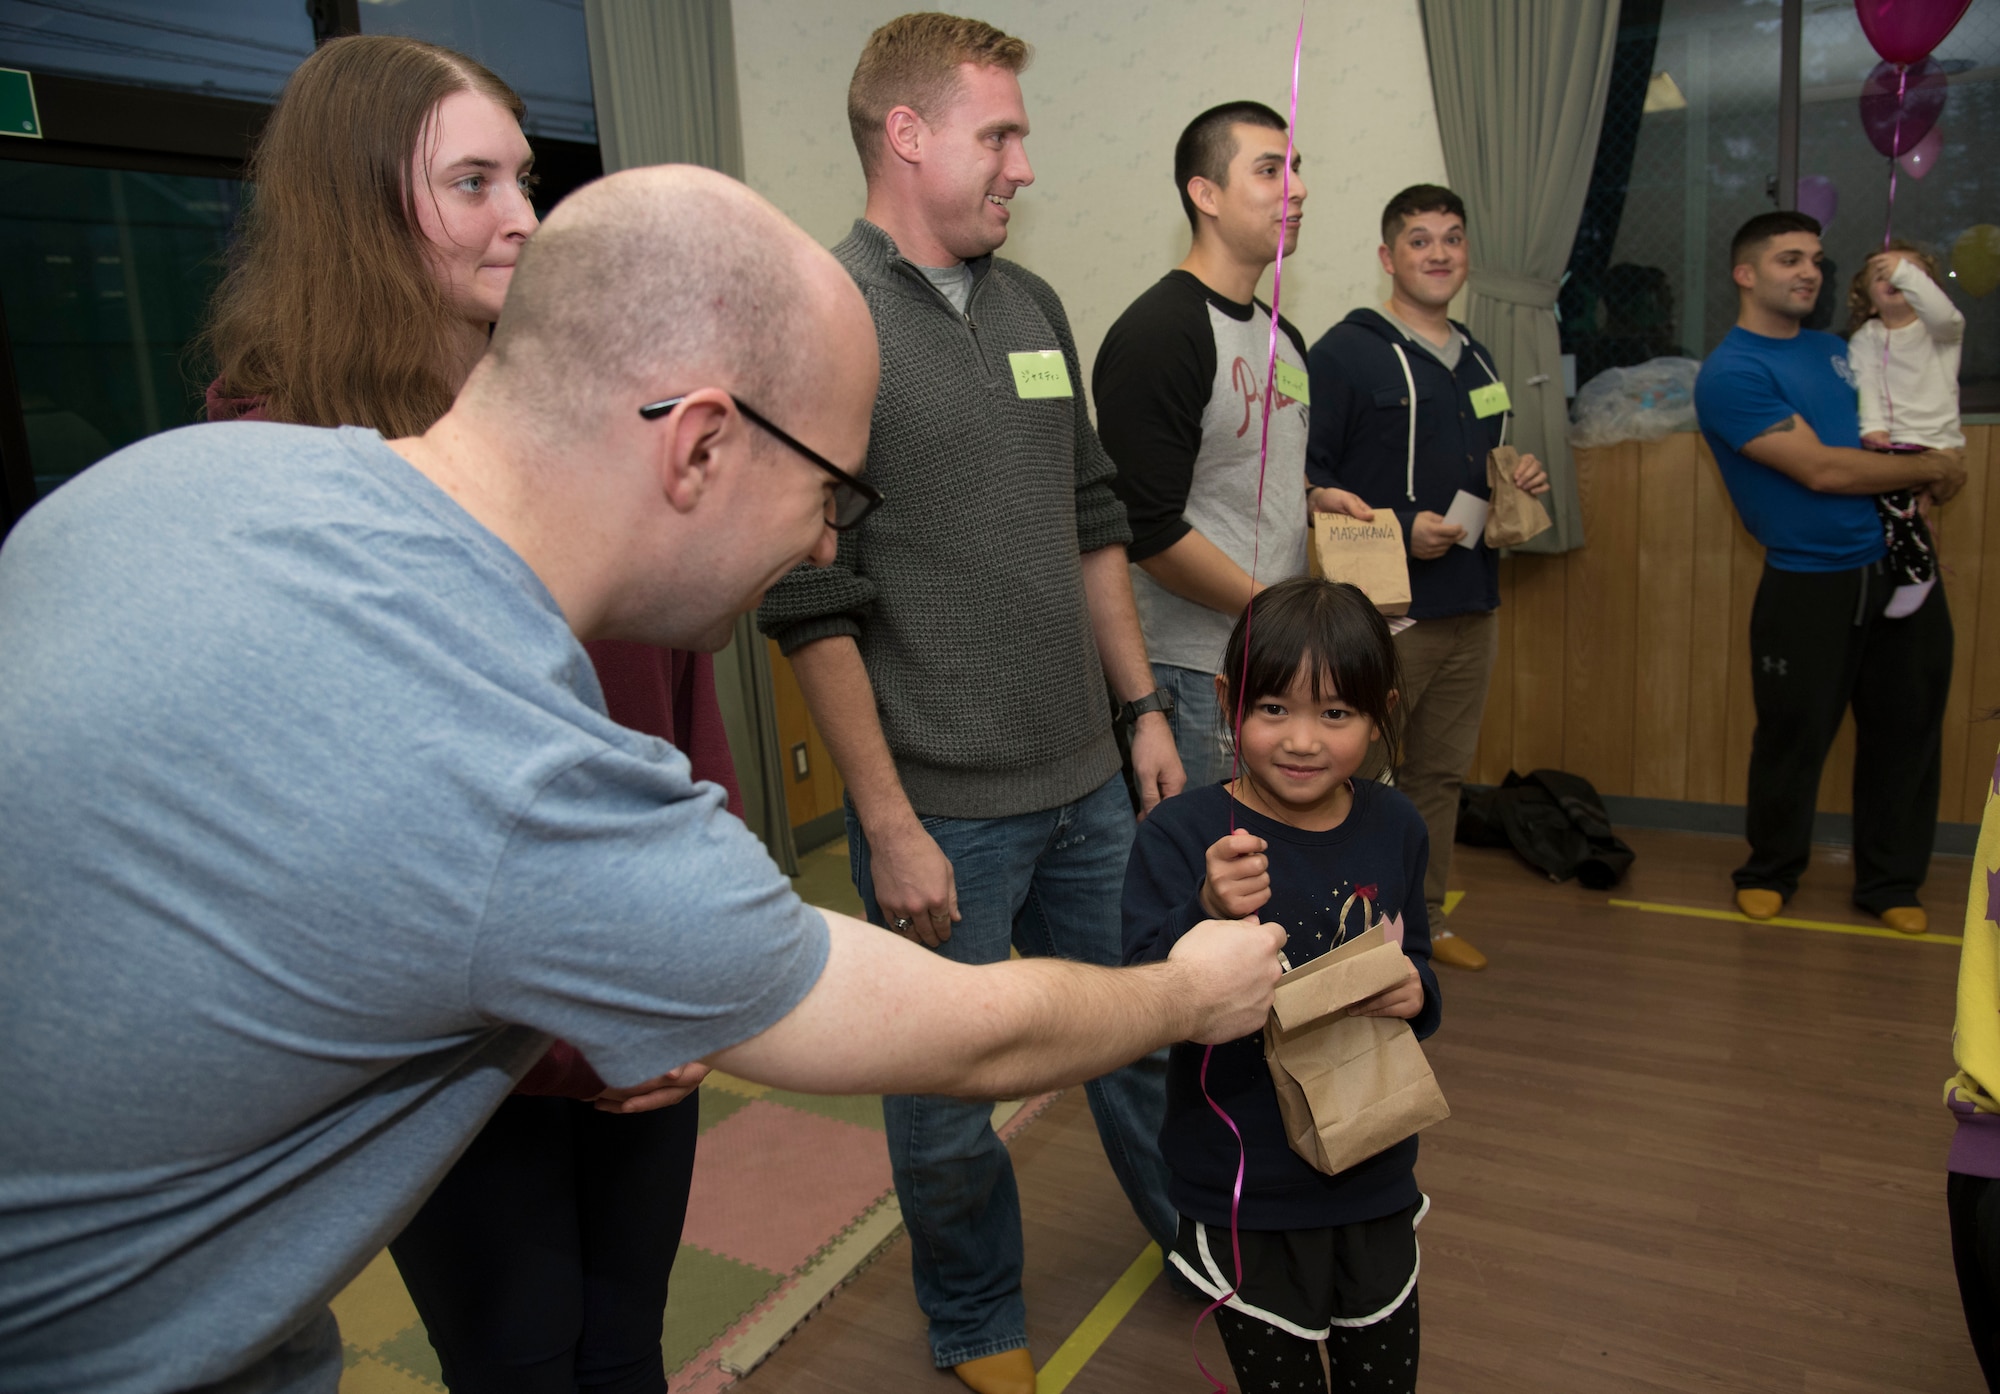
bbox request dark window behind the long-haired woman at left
[0,0,602,530]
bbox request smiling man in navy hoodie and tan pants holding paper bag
[1306,184,1548,968]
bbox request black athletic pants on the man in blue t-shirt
[1736,566,1952,914]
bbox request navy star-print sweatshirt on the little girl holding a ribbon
[1124,780,1438,1230]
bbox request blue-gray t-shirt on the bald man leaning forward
[0,422,826,1392]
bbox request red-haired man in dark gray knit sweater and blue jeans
[760,14,1182,1394]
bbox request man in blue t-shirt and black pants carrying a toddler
[1694,212,1966,934]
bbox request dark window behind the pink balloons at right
[1560,0,2000,414]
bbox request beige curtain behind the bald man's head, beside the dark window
[584,0,798,876]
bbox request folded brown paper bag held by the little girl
[1264,896,1452,1176]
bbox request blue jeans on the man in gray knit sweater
[846,778,1178,1370]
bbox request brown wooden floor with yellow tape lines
[742,832,1982,1394]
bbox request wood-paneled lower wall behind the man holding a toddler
[1472,426,2000,822]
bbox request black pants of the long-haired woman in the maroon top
[388,1094,700,1394]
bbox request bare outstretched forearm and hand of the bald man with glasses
[710,910,1284,1098]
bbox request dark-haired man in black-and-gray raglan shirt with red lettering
[1090,102,1372,788]
